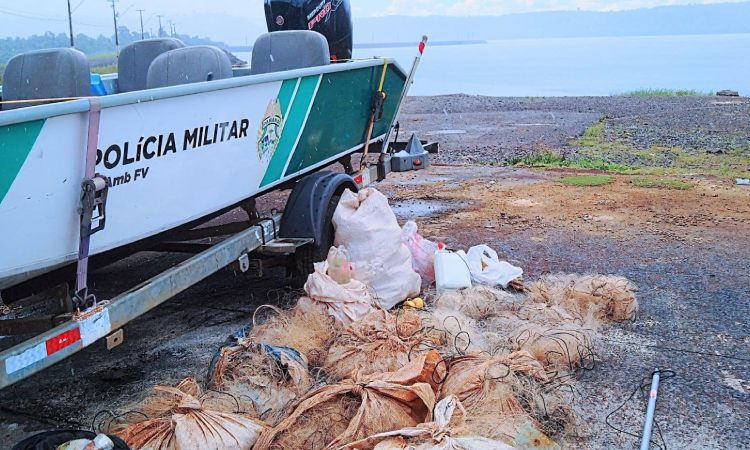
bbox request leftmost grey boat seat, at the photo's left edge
[3,48,91,110]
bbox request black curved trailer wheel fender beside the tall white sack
[279,171,358,261]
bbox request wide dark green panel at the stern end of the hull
[284,66,406,176]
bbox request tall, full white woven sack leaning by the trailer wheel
[333,188,422,309]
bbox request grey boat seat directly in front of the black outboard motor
[250,31,331,75]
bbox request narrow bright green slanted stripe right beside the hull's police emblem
[260,75,320,187]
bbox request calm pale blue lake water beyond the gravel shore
[236,34,750,96]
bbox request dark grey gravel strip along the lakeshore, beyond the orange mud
[403,95,750,164]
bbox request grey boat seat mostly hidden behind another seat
[117,38,185,92]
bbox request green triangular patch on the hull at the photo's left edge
[0,119,45,203]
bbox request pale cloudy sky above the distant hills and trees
[0,0,747,42]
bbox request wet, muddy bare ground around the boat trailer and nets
[0,96,750,450]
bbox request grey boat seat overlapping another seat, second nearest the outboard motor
[146,45,232,89]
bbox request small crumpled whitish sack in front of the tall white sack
[299,261,377,328]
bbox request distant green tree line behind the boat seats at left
[0,27,226,64]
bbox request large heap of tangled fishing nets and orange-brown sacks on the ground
[110,275,638,450]
